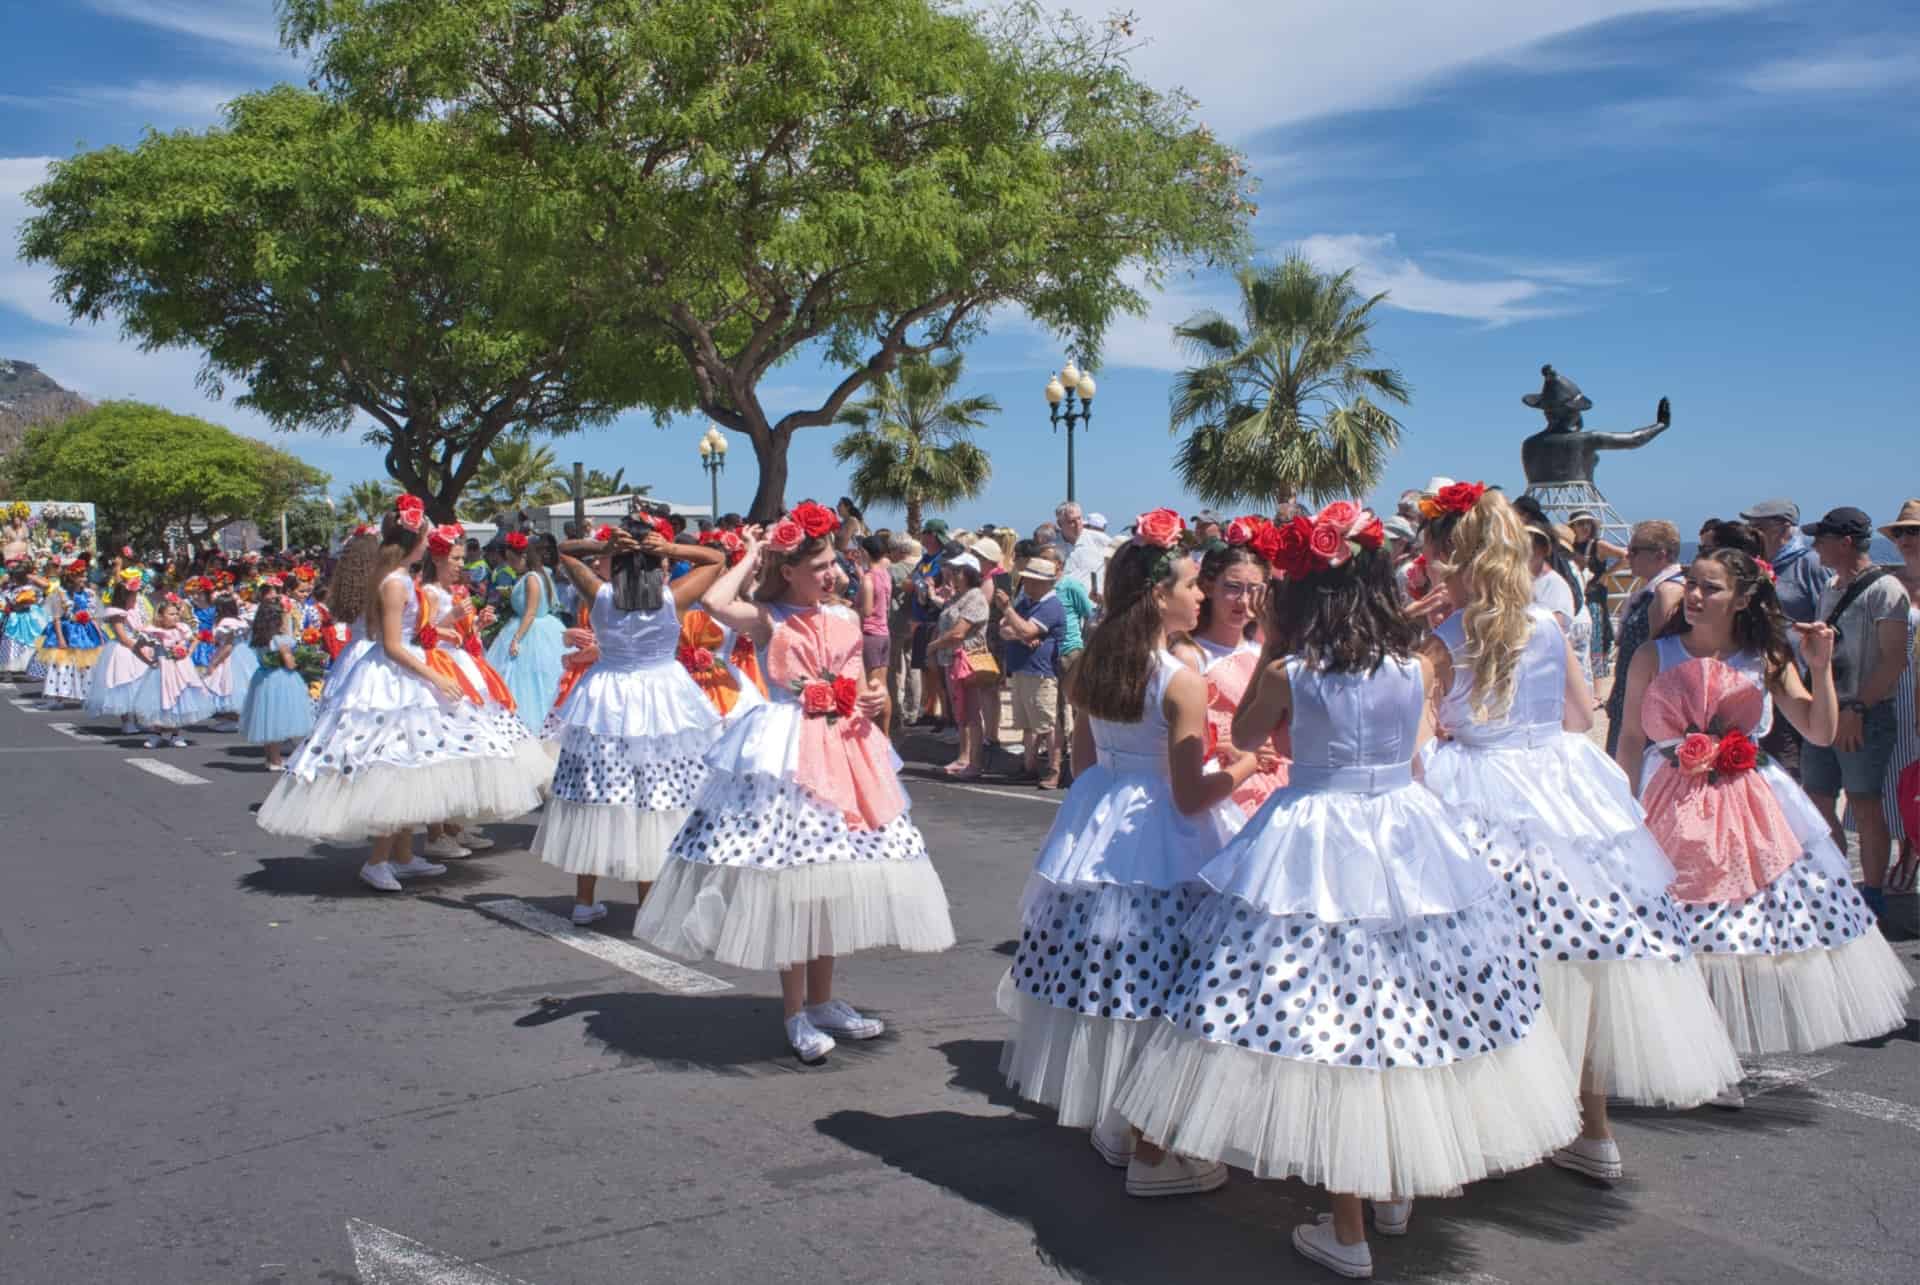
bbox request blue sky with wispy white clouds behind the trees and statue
[0,0,1920,528]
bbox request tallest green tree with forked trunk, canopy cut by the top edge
[282,0,1252,519]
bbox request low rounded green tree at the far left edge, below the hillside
[6,401,326,546]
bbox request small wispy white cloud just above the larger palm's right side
[1300,232,1584,327]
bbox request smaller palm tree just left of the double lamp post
[833,353,1000,536]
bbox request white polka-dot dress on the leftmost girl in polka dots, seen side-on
[257,569,551,843]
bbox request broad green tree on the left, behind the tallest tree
[21,86,687,521]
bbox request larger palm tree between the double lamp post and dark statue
[1171,254,1409,503]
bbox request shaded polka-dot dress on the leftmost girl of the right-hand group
[998,651,1242,1127]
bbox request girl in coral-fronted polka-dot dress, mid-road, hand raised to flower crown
[633,503,954,1062]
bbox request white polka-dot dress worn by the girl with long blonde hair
[1425,607,1740,1108]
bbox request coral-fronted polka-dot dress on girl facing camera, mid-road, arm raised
[634,605,954,968]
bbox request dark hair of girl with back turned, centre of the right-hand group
[1263,549,1421,674]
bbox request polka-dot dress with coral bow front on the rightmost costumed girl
[1640,638,1912,1055]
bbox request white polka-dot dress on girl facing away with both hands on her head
[532,584,720,884]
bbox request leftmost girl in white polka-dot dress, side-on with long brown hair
[259,496,551,891]
